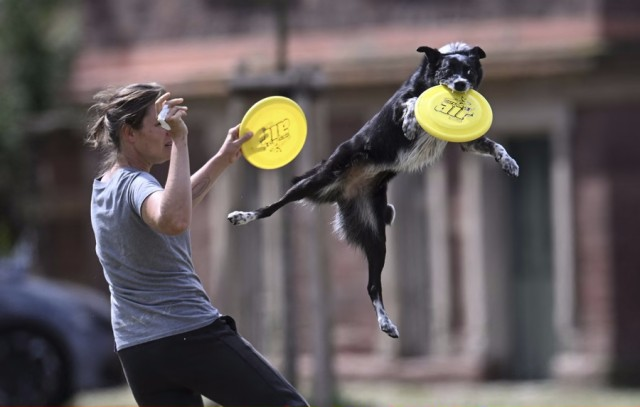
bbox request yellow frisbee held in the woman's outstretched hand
[240,96,307,170]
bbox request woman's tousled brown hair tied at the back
[85,83,165,173]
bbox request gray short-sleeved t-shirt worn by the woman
[91,168,220,350]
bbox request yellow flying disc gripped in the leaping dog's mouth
[415,85,493,143]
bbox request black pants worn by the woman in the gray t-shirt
[118,316,308,406]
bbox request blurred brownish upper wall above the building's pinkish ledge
[84,0,600,47]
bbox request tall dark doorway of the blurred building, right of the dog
[505,137,555,380]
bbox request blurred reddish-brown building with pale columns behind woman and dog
[36,0,640,384]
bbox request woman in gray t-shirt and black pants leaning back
[87,83,307,406]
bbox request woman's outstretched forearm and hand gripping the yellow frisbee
[191,125,252,208]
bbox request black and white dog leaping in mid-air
[227,42,519,338]
